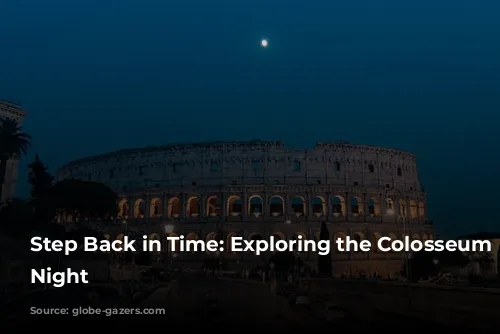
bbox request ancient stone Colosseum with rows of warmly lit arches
[58,141,433,277]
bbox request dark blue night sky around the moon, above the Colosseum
[0,0,500,236]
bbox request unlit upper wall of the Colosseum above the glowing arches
[58,141,421,193]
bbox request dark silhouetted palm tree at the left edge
[0,118,31,201]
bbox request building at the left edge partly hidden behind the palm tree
[0,99,25,202]
